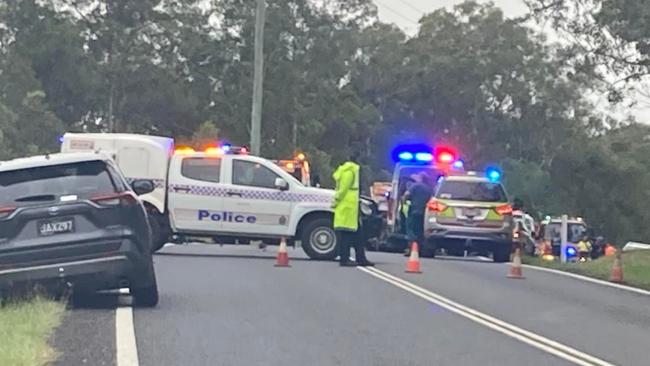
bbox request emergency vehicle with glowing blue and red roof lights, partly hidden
[381,144,464,250]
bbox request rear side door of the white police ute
[168,156,225,233]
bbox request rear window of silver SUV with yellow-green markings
[436,180,508,202]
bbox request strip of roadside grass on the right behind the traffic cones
[523,250,650,290]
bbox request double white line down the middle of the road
[358,267,614,366]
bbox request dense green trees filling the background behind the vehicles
[0,0,650,246]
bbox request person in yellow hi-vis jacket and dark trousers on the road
[332,152,374,266]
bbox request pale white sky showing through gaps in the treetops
[374,0,650,124]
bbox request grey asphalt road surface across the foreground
[54,245,650,366]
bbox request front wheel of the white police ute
[300,217,338,260]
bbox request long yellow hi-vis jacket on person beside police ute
[332,161,360,231]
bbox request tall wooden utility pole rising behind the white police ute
[251,0,266,155]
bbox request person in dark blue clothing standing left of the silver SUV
[404,172,433,256]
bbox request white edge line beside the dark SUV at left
[115,289,140,366]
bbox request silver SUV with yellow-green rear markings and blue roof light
[422,168,513,262]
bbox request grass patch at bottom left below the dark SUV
[0,296,65,366]
